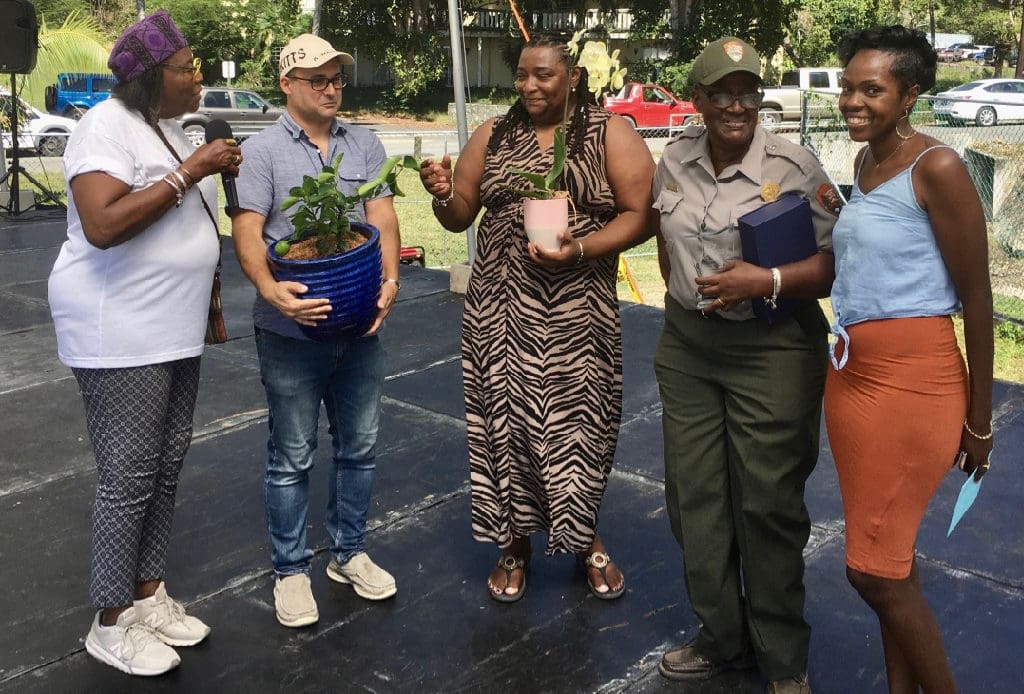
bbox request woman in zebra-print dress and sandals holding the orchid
[421,39,653,602]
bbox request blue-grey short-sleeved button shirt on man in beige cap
[236,113,393,340]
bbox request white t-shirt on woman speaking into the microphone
[48,98,218,368]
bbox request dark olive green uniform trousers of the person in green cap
[654,297,827,680]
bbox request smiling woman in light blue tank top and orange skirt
[824,27,992,692]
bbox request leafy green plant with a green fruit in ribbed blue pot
[266,155,419,342]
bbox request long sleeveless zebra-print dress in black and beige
[462,106,623,555]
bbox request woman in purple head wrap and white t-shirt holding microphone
[49,10,242,675]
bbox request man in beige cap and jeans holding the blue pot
[231,34,400,626]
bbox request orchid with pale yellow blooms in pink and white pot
[506,30,626,250]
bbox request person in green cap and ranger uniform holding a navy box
[653,37,836,694]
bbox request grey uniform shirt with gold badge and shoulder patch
[653,126,840,320]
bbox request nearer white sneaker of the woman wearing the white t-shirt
[85,607,181,677]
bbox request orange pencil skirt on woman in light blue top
[824,316,968,579]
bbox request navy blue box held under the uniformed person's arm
[737,192,818,324]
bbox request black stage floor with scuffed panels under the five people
[0,211,1024,694]
